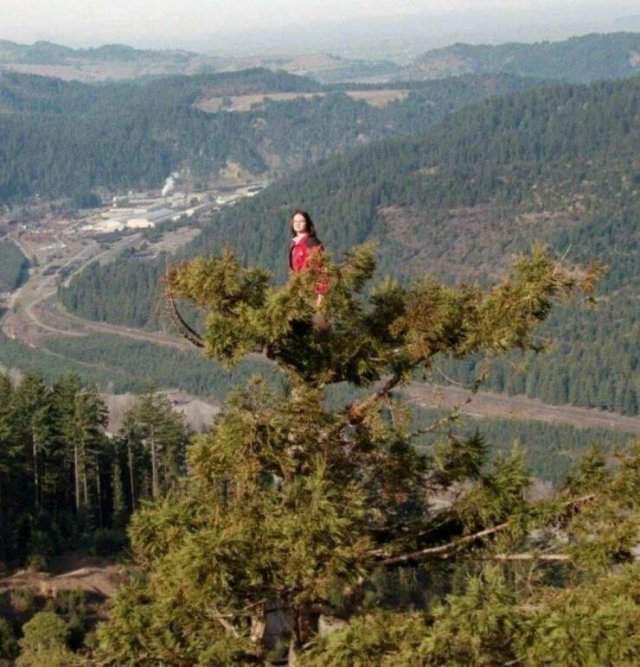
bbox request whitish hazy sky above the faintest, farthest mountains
[0,0,640,50]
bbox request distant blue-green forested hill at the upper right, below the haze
[408,32,640,83]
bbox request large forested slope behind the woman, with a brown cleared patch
[62,78,640,414]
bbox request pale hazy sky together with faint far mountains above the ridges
[10,0,638,57]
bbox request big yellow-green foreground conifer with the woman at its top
[98,246,596,666]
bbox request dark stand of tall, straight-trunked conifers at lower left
[0,375,190,567]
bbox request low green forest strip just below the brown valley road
[0,334,633,485]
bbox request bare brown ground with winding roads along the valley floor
[0,220,640,444]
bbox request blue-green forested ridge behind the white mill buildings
[0,70,534,204]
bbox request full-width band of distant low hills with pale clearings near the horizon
[0,32,640,83]
